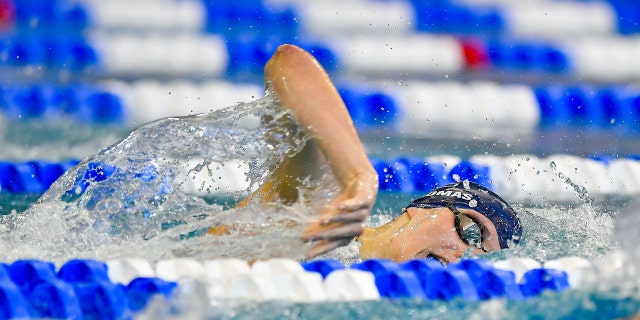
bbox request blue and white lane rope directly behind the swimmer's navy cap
[0,155,640,196]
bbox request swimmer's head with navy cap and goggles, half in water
[358,180,522,262]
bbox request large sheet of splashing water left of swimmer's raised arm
[0,93,332,261]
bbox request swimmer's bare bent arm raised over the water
[265,45,378,257]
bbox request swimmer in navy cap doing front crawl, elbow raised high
[210,45,522,262]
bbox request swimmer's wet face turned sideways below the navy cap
[360,207,500,263]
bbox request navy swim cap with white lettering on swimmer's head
[407,180,522,249]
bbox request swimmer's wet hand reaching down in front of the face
[302,173,378,259]
